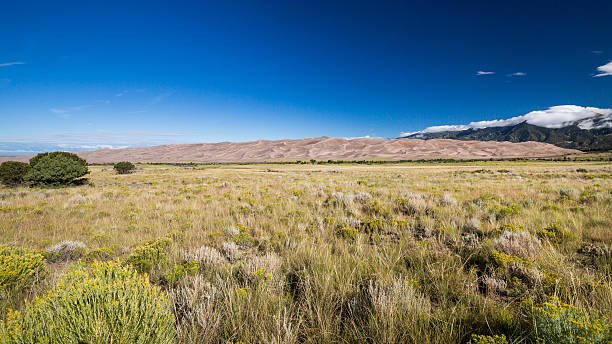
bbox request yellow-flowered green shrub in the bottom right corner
[533,297,612,344]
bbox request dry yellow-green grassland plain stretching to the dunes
[0,161,612,343]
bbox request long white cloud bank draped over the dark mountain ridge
[400,105,612,137]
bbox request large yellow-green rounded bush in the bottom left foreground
[0,262,176,344]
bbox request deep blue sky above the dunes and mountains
[0,1,612,154]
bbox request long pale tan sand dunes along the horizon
[0,137,579,163]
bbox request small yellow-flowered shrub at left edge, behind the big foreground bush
[0,245,46,292]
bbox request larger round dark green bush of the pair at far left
[24,152,89,185]
